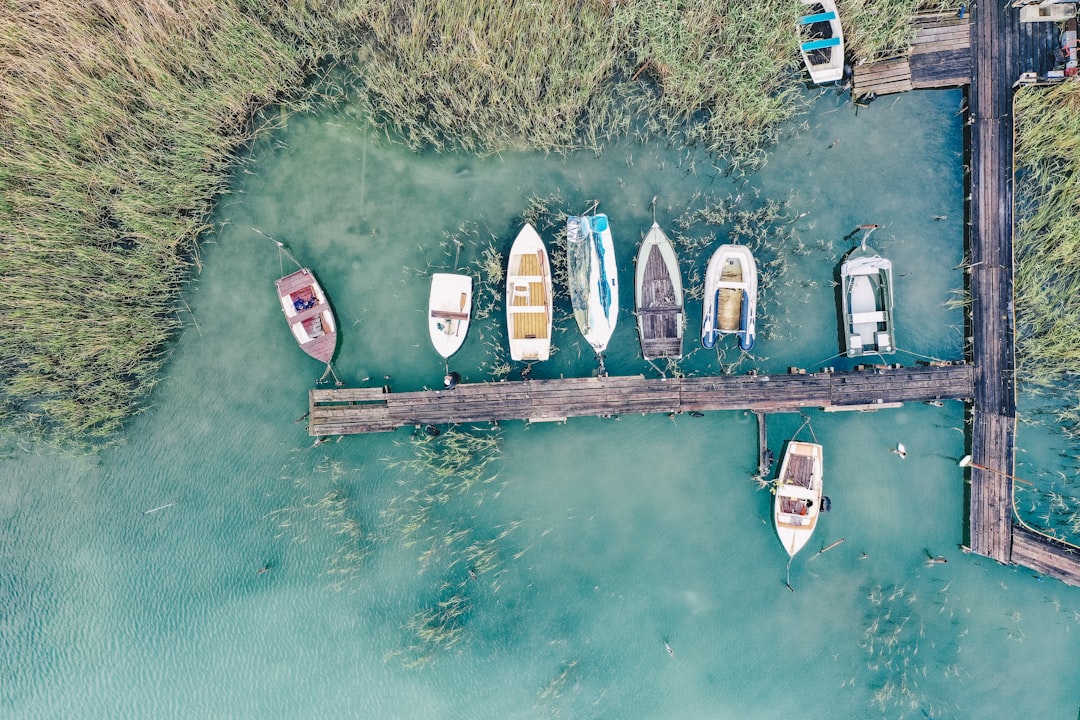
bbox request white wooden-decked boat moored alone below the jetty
[772,440,823,557]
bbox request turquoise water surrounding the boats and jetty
[0,91,1080,718]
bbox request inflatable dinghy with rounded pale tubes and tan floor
[701,245,757,351]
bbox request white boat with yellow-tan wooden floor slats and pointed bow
[507,223,552,362]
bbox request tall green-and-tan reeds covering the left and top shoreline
[0,0,989,445]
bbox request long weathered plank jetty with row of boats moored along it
[309,364,974,436]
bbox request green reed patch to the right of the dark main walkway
[1014,80,1080,435]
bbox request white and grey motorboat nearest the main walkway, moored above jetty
[840,225,896,357]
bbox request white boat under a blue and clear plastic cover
[566,213,619,362]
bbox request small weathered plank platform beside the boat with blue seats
[851,12,971,97]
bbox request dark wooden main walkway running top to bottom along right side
[968,3,1080,586]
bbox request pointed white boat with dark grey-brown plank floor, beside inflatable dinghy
[634,222,686,359]
